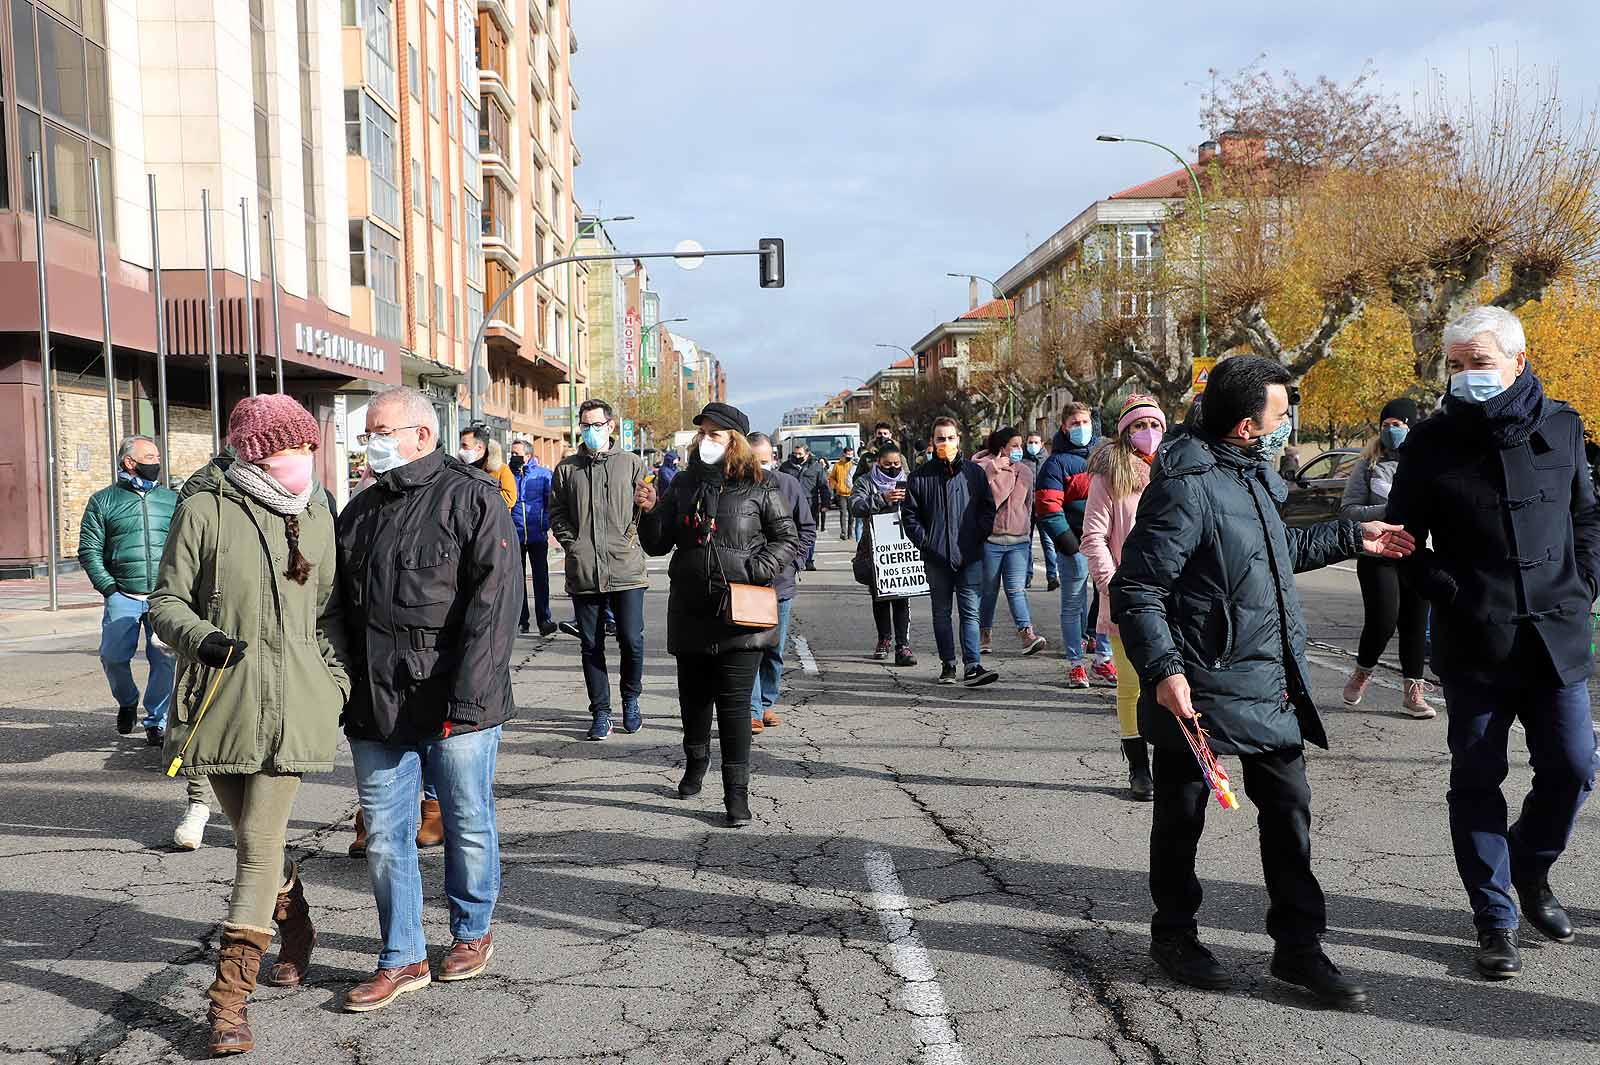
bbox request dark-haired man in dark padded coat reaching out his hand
[1110,357,1410,1006]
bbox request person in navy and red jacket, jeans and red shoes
[1034,403,1117,688]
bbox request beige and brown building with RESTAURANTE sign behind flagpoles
[0,0,398,572]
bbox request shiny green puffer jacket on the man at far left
[78,478,178,595]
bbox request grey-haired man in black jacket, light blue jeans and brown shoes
[339,389,522,1012]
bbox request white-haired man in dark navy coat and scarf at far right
[1389,307,1600,980]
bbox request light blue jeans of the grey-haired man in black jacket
[350,726,501,969]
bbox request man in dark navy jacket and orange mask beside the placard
[902,417,1000,688]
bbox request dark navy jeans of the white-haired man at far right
[1445,681,1595,932]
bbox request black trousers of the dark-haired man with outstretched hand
[1150,747,1328,948]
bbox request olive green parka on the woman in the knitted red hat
[150,480,350,776]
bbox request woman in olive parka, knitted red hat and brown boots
[150,395,350,1054]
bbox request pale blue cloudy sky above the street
[573,0,1600,429]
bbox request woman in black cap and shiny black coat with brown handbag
[638,403,800,828]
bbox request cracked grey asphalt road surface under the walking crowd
[0,534,1600,1065]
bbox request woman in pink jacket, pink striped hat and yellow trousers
[1082,395,1166,803]
